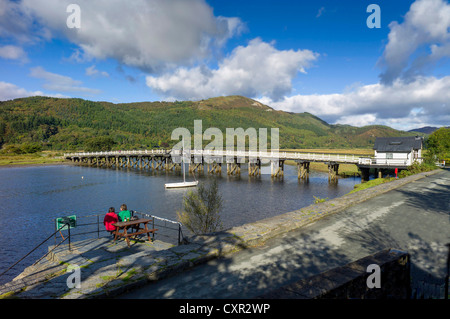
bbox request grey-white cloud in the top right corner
[379,0,450,84]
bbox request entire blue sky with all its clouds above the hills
[0,0,450,130]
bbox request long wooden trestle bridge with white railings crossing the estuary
[64,149,366,180]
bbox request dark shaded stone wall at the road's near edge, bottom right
[260,249,411,299]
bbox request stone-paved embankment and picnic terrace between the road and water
[0,170,441,299]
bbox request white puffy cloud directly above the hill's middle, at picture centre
[146,39,318,100]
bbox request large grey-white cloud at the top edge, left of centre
[11,0,243,72]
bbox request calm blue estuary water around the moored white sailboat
[0,165,360,283]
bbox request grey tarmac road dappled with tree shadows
[119,171,450,298]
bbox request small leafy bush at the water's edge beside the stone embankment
[177,180,222,235]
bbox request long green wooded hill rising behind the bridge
[0,96,416,150]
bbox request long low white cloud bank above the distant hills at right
[258,76,450,129]
